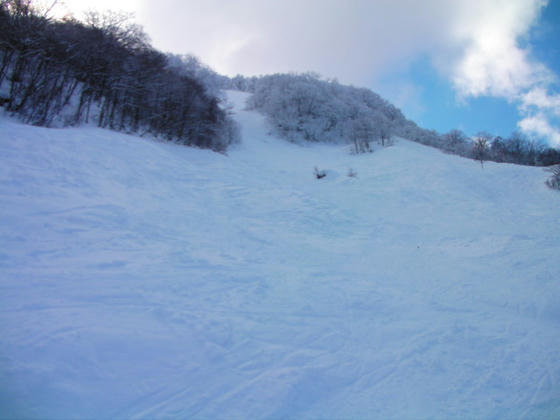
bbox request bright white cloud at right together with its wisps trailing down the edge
[450,0,560,146]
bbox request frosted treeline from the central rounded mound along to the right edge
[225,73,560,166]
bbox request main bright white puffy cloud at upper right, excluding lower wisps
[451,0,552,100]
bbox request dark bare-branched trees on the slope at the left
[0,0,237,150]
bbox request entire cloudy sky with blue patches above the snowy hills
[57,0,560,146]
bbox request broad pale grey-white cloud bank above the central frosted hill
[135,0,456,85]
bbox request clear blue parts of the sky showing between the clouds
[377,1,560,141]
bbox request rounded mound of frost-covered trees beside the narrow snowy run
[248,73,406,151]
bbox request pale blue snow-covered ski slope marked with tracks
[0,92,560,419]
